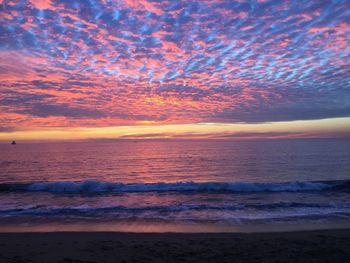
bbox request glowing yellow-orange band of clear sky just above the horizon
[0,118,350,141]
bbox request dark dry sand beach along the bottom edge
[0,229,350,263]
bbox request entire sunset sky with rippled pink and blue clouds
[0,0,350,140]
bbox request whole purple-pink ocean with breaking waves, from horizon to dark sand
[0,139,350,232]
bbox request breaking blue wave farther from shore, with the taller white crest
[0,180,350,193]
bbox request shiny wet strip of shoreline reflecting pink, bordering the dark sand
[0,222,350,234]
